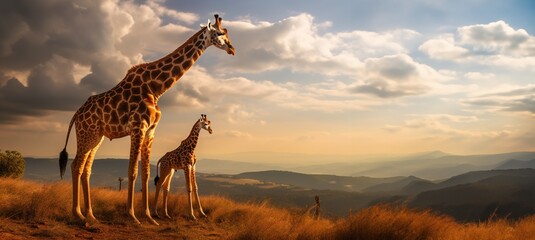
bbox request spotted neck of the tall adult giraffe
[129,27,209,99]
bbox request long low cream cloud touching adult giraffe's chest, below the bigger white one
[170,65,384,113]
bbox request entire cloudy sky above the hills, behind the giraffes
[0,0,535,161]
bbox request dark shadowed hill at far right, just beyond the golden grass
[409,169,535,221]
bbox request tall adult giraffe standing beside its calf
[59,14,234,225]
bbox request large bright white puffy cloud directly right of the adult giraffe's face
[213,13,451,100]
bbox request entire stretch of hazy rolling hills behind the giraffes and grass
[19,152,535,221]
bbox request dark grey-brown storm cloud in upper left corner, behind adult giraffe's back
[0,0,128,123]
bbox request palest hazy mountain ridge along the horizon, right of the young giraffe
[186,151,535,180]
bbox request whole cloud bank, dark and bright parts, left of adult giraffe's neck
[0,0,201,122]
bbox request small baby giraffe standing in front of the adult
[154,114,212,220]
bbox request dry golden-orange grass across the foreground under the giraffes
[0,179,535,240]
